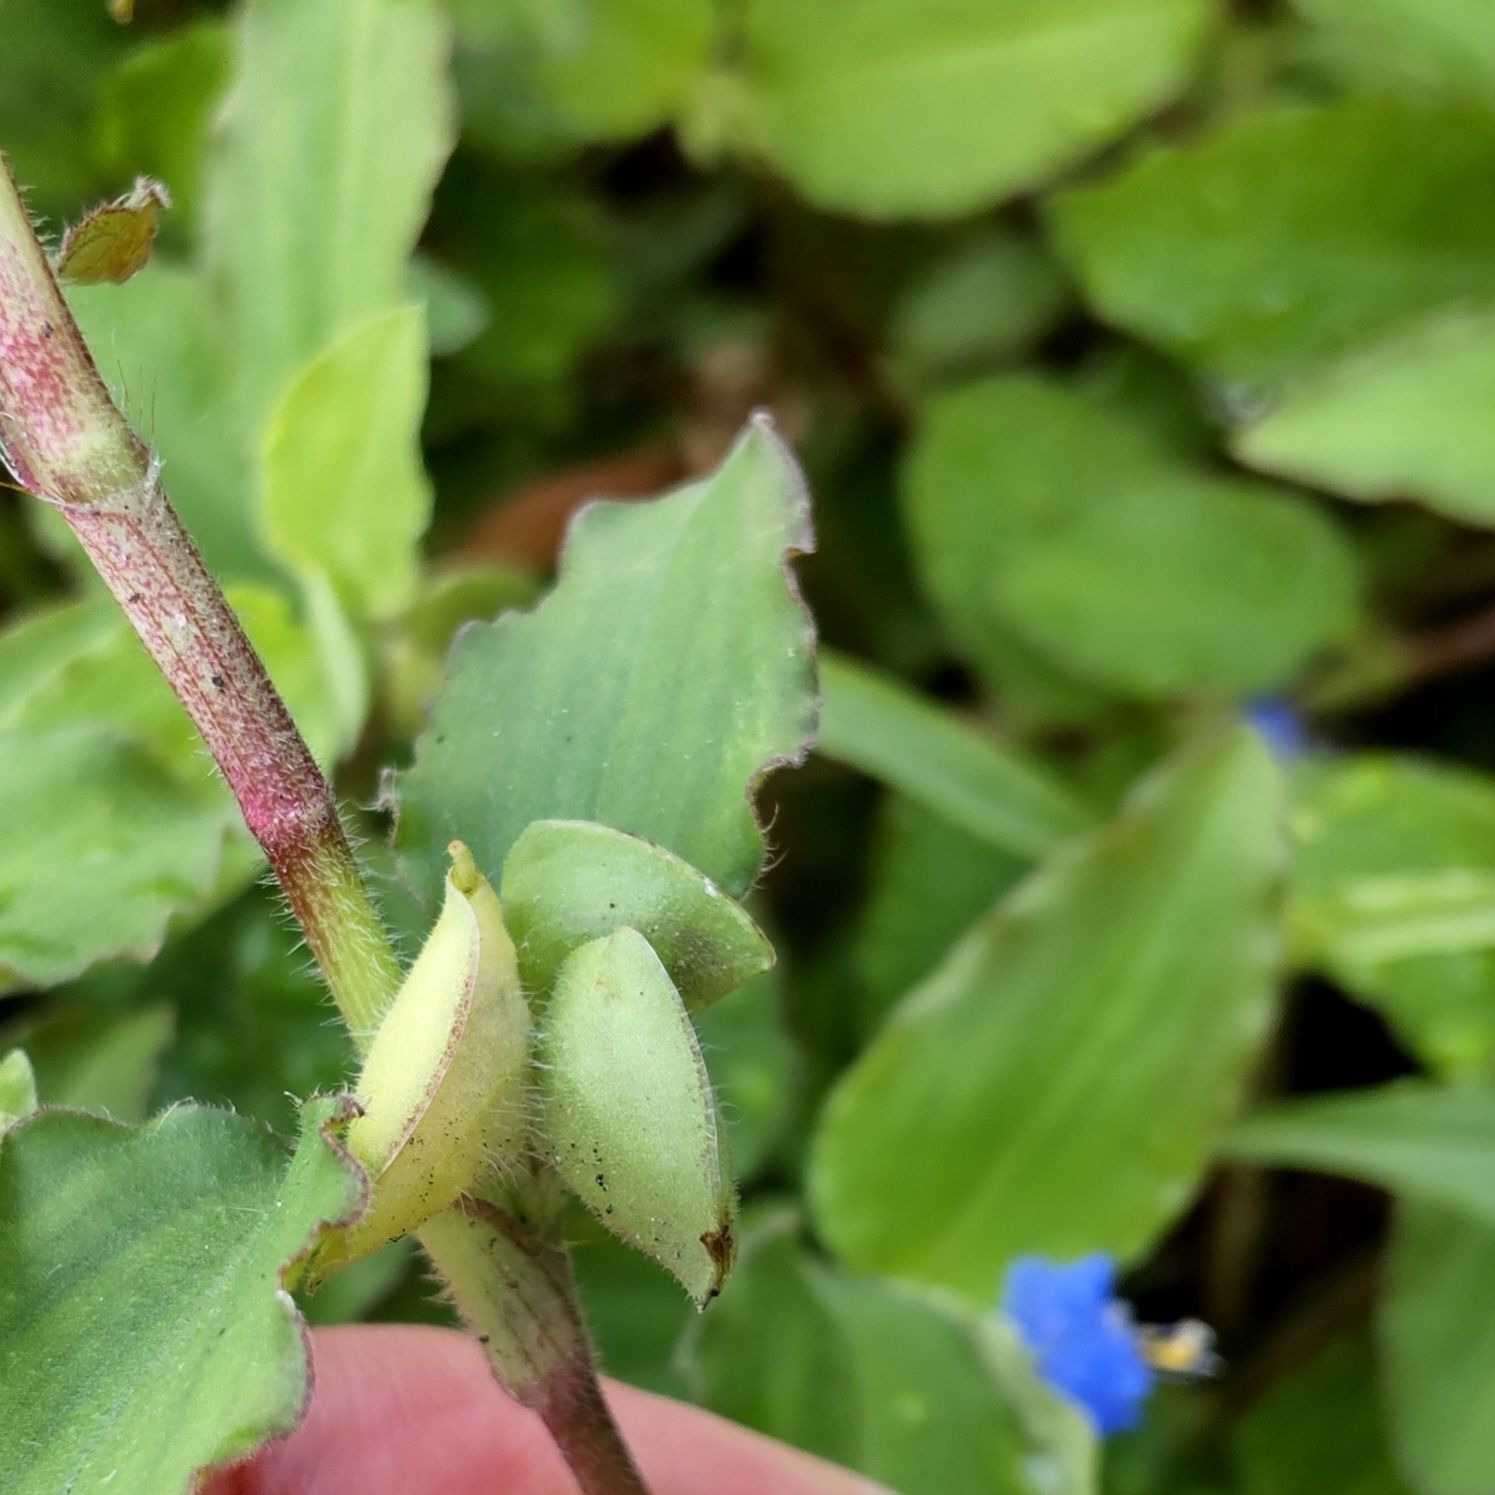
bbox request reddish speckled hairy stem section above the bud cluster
[0,154,399,1039]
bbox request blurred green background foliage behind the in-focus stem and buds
[0,0,1495,1495]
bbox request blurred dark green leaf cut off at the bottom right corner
[1378,1203,1495,1495]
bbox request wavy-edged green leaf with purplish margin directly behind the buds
[393,423,815,897]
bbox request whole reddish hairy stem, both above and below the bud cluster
[0,157,644,1495]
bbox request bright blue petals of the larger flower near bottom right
[1002,1251,1153,1434]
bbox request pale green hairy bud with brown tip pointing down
[540,927,736,1307]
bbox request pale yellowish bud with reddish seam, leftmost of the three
[318,842,529,1272]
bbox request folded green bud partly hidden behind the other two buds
[502,821,773,1012]
